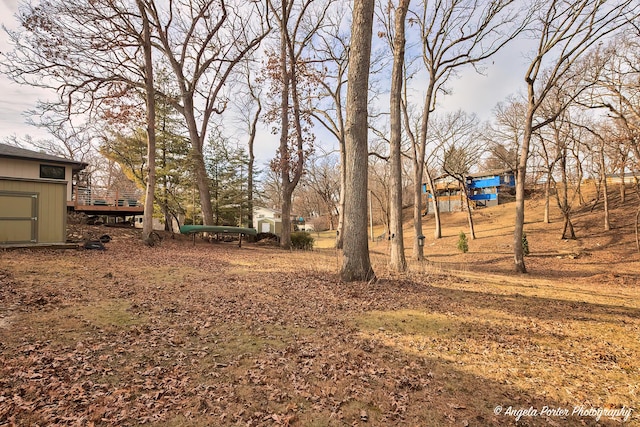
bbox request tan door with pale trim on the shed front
[0,191,38,243]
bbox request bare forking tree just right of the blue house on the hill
[513,0,640,273]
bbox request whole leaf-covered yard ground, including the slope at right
[0,192,640,426]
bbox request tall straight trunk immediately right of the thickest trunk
[389,0,409,272]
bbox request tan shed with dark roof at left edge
[0,144,87,245]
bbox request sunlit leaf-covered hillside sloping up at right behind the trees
[356,187,640,283]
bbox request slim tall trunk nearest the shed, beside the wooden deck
[137,0,156,246]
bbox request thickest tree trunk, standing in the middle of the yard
[340,0,375,282]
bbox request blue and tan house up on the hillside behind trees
[423,169,516,213]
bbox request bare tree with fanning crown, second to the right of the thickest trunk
[405,0,527,260]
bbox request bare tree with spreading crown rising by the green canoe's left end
[143,0,270,225]
